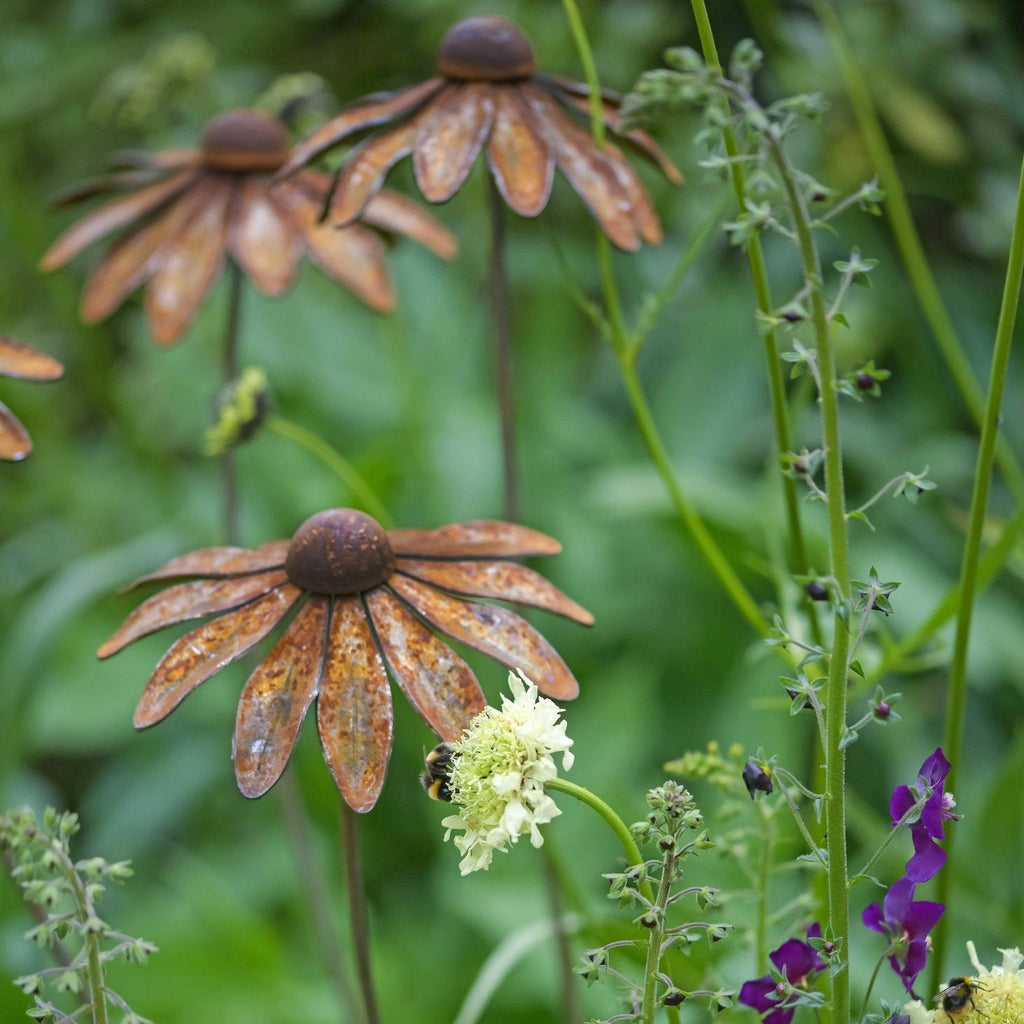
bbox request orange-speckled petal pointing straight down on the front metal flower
[316,597,393,813]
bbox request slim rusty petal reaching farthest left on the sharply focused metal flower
[96,569,288,657]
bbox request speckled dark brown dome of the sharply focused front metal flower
[285,509,394,594]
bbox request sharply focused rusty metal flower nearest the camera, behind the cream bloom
[98,509,593,811]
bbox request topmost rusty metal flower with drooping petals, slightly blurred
[279,17,681,250]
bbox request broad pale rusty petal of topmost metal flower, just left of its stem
[413,82,495,203]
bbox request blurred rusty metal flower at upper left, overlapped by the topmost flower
[40,110,457,344]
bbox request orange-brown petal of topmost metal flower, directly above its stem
[487,87,555,217]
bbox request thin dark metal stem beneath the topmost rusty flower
[487,175,519,522]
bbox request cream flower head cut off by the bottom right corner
[903,942,1024,1024]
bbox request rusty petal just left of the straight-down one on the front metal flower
[232,595,330,799]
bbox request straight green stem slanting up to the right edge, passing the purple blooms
[932,149,1024,990]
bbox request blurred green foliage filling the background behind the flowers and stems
[0,0,1024,1024]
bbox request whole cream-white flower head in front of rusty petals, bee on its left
[441,672,572,874]
